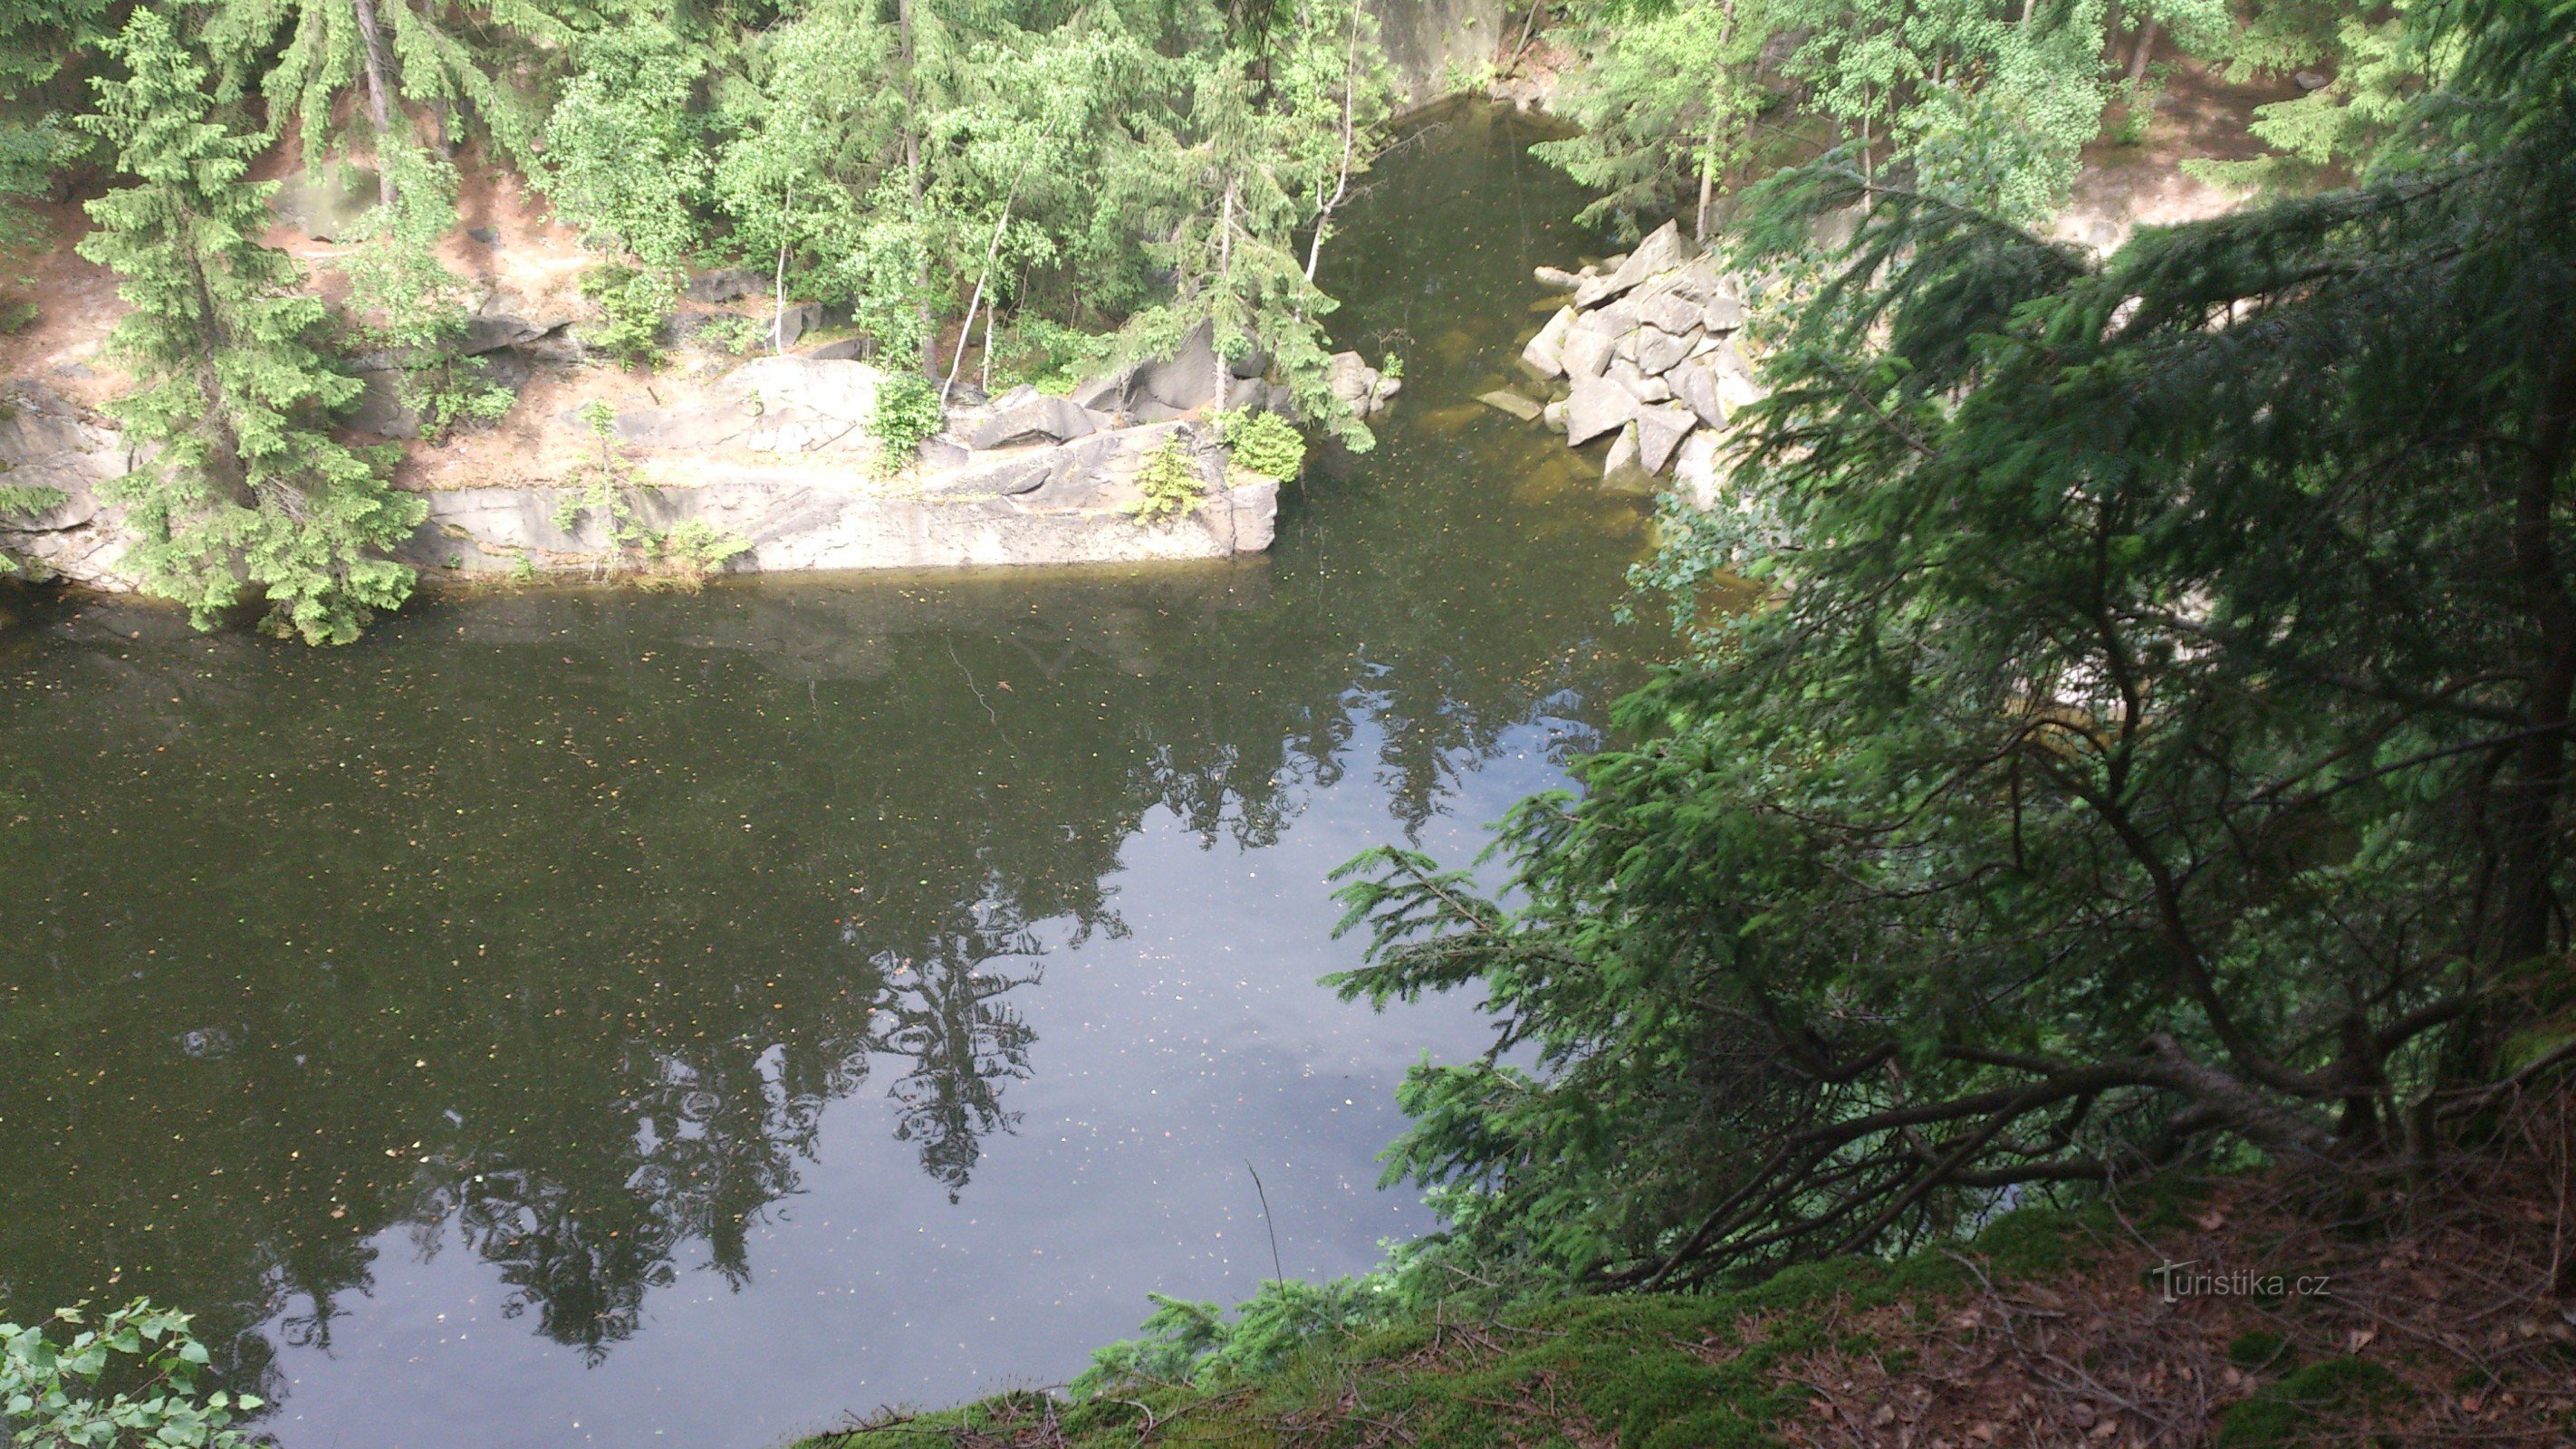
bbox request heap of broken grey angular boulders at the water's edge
[1520,221,1762,507]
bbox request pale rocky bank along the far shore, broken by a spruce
[0,317,1399,592]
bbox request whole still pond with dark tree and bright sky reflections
[0,108,1648,1449]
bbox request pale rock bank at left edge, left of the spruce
[0,383,134,592]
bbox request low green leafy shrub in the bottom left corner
[0,1297,260,1449]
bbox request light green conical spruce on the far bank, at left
[80,10,428,643]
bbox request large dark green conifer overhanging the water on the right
[1340,0,2576,1287]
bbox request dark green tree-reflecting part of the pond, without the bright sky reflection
[0,99,1643,1441]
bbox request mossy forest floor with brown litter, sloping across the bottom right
[803,1097,2576,1449]
